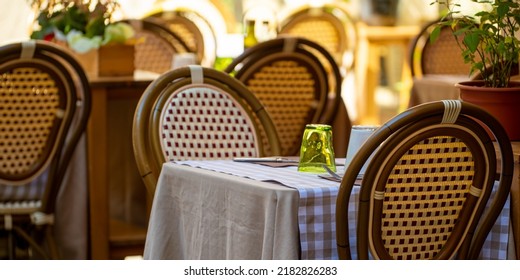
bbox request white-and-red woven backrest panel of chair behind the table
[160,86,258,160]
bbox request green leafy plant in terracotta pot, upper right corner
[430,0,520,140]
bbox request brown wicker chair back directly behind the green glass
[224,36,342,155]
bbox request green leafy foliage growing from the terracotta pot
[430,0,520,87]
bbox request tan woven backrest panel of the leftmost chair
[0,68,64,178]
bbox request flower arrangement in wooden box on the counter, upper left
[30,0,137,76]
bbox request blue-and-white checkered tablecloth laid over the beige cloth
[175,160,510,260]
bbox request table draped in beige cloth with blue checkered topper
[144,160,509,259]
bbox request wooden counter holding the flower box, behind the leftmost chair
[87,73,153,260]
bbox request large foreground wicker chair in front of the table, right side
[336,100,513,259]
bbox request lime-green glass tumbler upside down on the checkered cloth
[298,124,336,173]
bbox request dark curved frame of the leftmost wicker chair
[0,40,91,259]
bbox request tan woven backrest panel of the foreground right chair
[381,137,474,259]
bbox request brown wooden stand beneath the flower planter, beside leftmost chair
[87,71,158,259]
